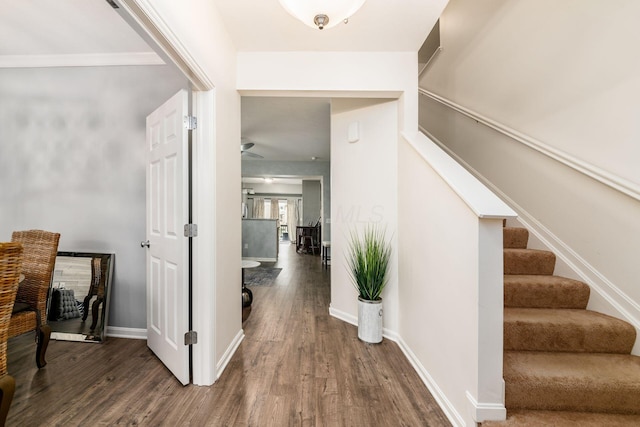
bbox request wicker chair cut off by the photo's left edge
[0,243,22,426]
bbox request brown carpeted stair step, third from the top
[504,274,590,308]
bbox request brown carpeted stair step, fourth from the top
[504,308,636,354]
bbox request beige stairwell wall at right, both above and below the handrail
[420,0,640,346]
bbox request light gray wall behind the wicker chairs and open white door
[0,66,187,328]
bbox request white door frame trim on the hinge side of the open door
[116,0,218,386]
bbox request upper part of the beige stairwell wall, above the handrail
[420,0,640,189]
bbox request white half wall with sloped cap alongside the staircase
[398,134,514,426]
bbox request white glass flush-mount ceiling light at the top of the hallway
[280,0,365,30]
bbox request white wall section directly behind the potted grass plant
[330,99,399,339]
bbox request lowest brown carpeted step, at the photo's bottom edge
[482,410,640,427]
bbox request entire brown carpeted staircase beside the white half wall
[482,227,640,427]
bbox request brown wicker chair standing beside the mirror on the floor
[9,230,60,368]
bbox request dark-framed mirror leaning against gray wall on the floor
[47,252,115,343]
